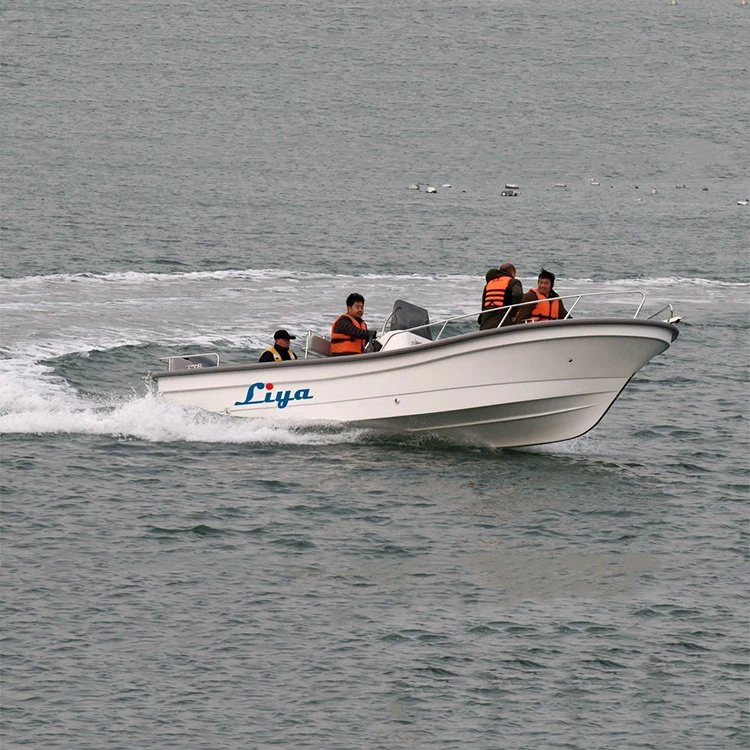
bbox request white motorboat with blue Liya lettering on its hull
[151,291,680,448]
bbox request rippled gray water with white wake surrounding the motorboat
[0,0,750,749]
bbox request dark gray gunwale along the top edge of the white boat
[150,318,680,380]
